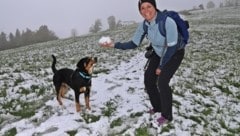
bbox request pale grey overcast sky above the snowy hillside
[0,0,221,38]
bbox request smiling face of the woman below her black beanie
[140,2,157,21]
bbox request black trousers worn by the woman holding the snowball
[144,49,184,121]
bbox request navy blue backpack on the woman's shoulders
[143,10,189,48]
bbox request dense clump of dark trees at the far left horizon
[0,25,58,50]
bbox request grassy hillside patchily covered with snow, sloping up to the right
[0,8,240,136]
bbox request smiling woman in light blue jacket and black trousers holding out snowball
[100,0,184,125]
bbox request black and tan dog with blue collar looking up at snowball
[52,55,97,112]
